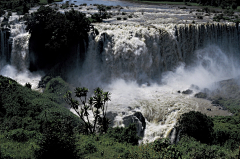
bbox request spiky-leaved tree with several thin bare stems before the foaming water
[65,87,110,134]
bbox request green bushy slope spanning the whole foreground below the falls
[0,76,240,159]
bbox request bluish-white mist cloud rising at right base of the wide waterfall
[162,45,240,90]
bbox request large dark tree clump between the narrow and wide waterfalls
[25,6,91,69]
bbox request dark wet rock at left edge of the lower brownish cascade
[123,112,146,137]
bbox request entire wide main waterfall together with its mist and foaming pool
[74,24,240,143]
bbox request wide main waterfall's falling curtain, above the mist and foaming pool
[79,24,240,87]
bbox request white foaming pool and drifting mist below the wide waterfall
[98,46,236,143]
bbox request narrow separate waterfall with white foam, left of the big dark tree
[0,20,41,89]
